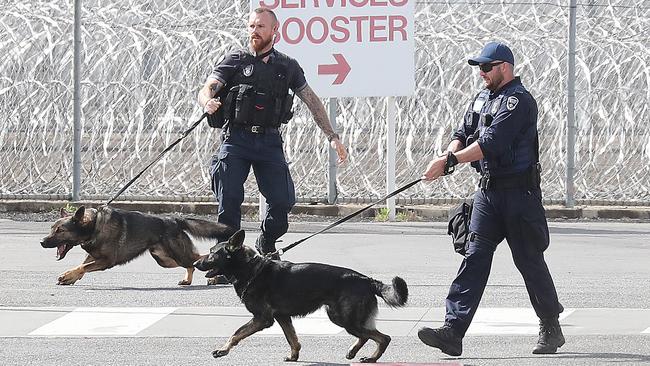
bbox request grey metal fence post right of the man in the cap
[565,0,576,208]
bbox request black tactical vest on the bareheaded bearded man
[208,51,293,128]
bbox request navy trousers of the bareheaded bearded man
[210,128,296,242]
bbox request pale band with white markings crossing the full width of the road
[0,307,650,337]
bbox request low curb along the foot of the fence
[0,200,650,221]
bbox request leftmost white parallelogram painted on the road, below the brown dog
[29,308,176,337]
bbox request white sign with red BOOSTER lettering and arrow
[251,0,415,97]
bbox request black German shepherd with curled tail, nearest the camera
[194,230,408,362]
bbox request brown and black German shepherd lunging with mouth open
[41,206,235,285]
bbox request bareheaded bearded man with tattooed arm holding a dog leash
[198,8,347,258]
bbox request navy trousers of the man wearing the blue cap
[445,188,560,336]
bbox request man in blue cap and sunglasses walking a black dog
[418,42,564,356]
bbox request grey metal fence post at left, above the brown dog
[72,0,81,201]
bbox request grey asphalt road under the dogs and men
[0,219,650,365]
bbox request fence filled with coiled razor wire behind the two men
[0,0,650,205]
